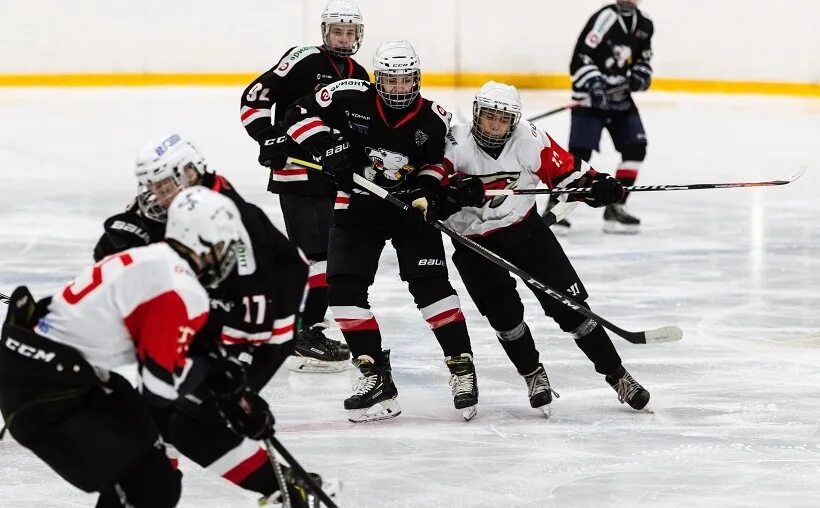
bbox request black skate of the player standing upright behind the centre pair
[288,323,350,372]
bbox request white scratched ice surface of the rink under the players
[0,87,820,508]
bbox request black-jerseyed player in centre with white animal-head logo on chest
[285,41,478,422]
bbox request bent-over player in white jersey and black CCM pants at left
[0,188,251,508]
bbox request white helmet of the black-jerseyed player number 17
[135,134,208,222]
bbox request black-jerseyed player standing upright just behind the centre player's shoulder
[241,0,370,372]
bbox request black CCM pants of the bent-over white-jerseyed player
[0,325,182,508]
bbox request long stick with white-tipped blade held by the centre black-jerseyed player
[289,155,683,344]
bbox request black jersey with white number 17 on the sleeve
[94,173,308,344]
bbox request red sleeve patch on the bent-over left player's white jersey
[124,291,208,374]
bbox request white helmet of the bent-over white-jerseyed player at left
[165,185,244,288]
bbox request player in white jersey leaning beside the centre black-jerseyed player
[442,81,649,414]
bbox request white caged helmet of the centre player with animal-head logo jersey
[373,41,421,109]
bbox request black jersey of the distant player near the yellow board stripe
[569,4,655,105]
